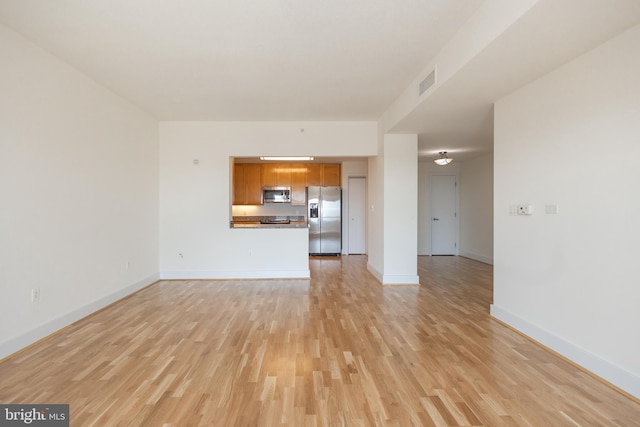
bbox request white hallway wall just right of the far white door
[458,153,493,264]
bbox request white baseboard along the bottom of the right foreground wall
[491,304,640,399]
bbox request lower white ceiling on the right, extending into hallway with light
[392,0,640,160]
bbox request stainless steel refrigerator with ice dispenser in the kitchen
[307,187,342,255]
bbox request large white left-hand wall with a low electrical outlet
[0,26,158,358]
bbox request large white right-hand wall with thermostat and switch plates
[492,26,640,397]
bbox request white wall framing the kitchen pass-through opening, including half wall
[160,122,377,278]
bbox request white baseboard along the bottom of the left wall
[0,274,159,359]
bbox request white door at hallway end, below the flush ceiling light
[431,175,458,255]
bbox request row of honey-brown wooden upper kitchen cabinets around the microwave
[233,163,340,205]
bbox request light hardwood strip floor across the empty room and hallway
[0,256,640,426]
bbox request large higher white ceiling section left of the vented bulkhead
[0,0,481,120]
